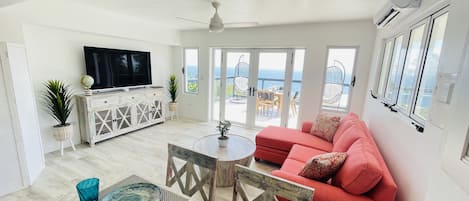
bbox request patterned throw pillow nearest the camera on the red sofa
[299,152,347,182]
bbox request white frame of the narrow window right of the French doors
[319,45,360,114]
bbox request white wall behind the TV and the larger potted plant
[23,25,172,152]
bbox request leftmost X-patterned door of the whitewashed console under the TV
[93,108,114,140]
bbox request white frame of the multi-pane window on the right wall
[375,5,449,127]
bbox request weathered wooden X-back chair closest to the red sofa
[233,165,314,201]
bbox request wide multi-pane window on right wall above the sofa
[377,9,448,124]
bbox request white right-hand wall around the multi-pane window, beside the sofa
[363,0,469,201]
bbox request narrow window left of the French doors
[184,48,199,93]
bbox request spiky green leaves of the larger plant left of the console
[44,80,72,126]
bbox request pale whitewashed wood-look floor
[0,120,278,201]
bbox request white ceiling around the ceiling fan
[74,0,387,30]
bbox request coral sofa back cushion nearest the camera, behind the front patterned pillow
[332,139,383,195]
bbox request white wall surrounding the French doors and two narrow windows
[175,20,376,124]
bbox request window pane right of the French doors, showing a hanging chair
[321,48,357,112]
